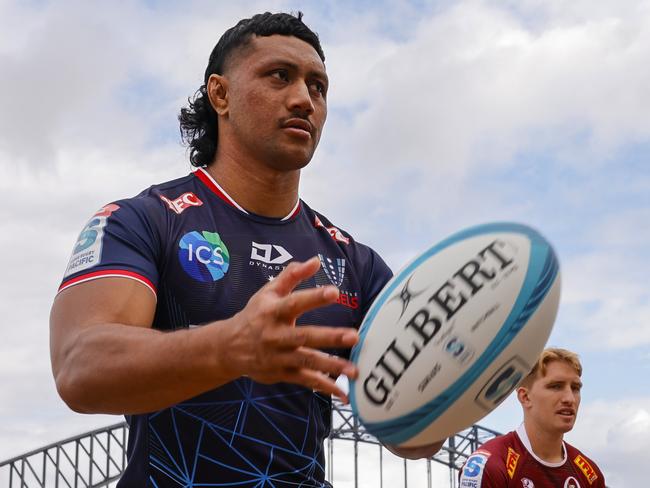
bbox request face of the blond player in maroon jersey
[522,361,582,434]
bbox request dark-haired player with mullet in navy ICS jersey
[51,13,441,487]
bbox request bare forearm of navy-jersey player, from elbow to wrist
[55,321,236,414]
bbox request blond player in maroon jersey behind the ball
[460,348,605,488]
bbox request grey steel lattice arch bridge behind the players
[0,401,499,488]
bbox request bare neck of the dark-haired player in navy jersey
[206,151,300,218]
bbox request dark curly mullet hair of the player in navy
[178,12,325,166]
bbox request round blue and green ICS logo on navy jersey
[178,230,230,282]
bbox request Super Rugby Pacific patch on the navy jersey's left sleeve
[63,203,120,278]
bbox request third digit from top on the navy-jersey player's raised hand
[267,325,359,349]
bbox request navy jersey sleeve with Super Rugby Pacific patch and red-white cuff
[59,199,160,294]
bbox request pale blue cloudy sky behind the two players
[0,0,650,487]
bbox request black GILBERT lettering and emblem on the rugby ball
[360,240,514,408]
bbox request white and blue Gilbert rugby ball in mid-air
[350,223,560,447]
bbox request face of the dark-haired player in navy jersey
[219,35,328,171]
